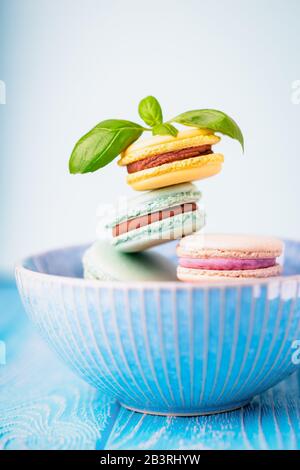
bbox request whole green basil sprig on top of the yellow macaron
[69,96,244,174]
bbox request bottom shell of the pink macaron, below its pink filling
[177,264,282,282]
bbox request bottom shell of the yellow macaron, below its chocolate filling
[127,153,224,191]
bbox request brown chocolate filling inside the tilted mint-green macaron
[112,202,197,237]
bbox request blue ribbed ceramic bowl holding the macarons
[16,242,300,415]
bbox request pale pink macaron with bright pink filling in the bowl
[177,233,283,282]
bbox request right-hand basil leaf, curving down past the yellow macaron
[170,109,244,150]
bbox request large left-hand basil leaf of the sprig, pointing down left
[69,119,144,174]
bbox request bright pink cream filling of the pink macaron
[179,258,276,271]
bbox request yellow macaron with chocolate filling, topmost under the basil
[118,128,224,191]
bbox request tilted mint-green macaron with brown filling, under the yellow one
[105,183,205,253]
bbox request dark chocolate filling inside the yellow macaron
[127,145,213,173]
